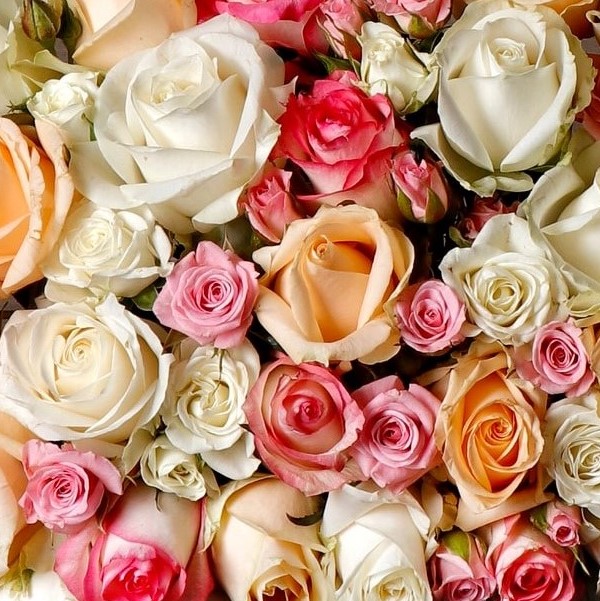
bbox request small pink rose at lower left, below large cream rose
[19,440,123,532]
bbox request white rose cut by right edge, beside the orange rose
[542,389,600,517]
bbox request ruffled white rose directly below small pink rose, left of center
[162,338,260,480]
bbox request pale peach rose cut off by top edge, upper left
[71,0,196,71]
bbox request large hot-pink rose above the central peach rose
[272,72,404,219]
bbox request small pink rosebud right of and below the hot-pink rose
[392,150,448,223]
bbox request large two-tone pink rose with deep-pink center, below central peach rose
[244,356,364,495]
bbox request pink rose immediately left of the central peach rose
[153,241,258,348]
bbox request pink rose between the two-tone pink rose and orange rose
[351,376,441,493]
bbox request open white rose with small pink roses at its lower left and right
[440,214,568,344]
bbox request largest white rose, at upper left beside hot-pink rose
[71,14,290,233]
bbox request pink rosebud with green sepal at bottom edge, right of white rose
[428,530,496,601]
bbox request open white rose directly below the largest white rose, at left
[42,199,173,302]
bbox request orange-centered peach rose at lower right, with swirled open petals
[435,343,546,530]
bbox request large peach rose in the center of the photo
[253,206,414,364]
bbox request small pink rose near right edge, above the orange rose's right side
[515,321,595,397]
